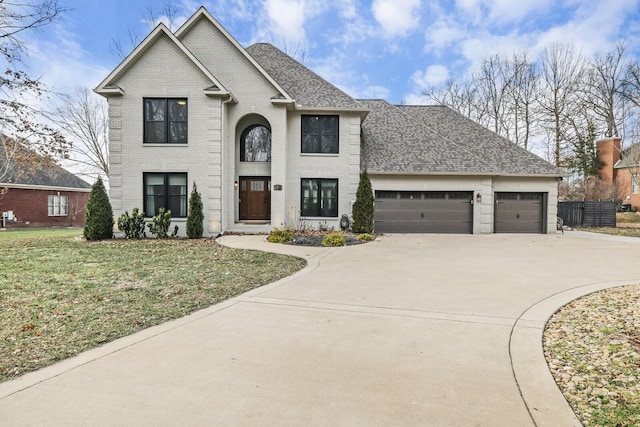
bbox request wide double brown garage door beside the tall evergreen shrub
[374,191,473,234]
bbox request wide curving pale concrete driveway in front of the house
[0,232,640,426]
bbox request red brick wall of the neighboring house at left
[0,188,89,228]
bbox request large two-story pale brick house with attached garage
[95,8,564,235]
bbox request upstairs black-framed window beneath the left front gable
[144,98,187,144]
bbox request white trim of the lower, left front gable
[94,23,232,96]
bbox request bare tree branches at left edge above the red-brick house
[0,0,68,181]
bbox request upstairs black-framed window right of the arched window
[302,115,340,154]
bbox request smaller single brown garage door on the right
[495,193,544,233]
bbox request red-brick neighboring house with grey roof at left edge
[0,145,91,228]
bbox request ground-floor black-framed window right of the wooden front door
[300,178,338,217]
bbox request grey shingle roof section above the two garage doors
[359,100,565,176]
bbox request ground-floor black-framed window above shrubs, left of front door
[143,172,187,218]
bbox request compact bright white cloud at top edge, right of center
[371,0,420,37]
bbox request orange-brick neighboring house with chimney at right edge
[596,138,640,210]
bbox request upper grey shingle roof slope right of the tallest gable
[246,43,363,110]
